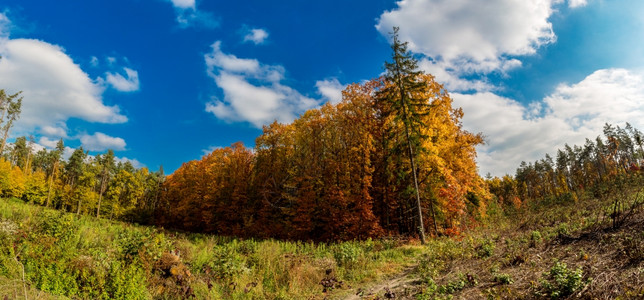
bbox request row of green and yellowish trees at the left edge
[0,137,165,223]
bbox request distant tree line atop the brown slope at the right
[486,123,644,206]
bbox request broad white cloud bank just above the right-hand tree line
[452,69,644,176]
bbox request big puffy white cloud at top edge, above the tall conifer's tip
[376,0,559,77]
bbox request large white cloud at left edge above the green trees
[0,39,127,137]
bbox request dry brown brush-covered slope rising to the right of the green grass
[399,187,644,299]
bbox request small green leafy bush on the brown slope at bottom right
[537,262,587,299]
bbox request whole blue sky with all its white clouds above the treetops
[0,0,644,176]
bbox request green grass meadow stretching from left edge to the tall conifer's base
[0,199,424,299]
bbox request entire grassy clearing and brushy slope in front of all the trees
[0,175,644,299]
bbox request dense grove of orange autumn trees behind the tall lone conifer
[157,75,487,240]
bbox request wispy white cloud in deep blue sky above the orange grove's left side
[205,42,319,127]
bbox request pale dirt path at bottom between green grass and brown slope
[344,266,420,300]
